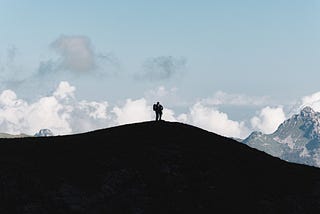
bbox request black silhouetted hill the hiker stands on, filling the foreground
[0,122,320,214]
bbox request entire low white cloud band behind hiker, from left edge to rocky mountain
[0,81,292,138]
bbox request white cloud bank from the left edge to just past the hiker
[0,81,175,135]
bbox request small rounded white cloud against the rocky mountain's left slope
[250,106,286,134]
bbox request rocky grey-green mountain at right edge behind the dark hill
[243,107,320,167]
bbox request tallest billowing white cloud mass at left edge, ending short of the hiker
[0,82,110,135]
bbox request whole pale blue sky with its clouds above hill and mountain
[0,0,320,138]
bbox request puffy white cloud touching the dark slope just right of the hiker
[185,102,248,138]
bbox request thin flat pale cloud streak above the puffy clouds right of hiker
[202,91,270,106]
